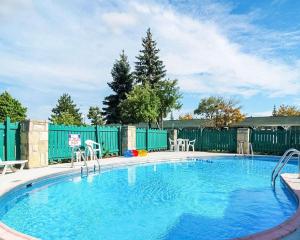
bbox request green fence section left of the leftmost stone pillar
[0,118,20,161]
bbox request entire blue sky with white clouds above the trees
[0,0,300,119]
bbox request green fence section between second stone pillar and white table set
[136,128,168,151]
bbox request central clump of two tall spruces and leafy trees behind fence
[103,29,181,127]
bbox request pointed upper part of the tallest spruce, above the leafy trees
[135,28,166,87]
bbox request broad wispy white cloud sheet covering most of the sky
[0,0,300,117]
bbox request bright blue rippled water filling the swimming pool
[0,157,297,240]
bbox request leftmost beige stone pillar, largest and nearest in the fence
[21,120,48,168]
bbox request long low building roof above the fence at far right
[232,116,300,127]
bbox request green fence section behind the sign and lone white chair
[48,124,120,161]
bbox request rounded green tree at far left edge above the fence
[0,91,27,122]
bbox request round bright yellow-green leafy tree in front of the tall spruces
[120,84,160,123]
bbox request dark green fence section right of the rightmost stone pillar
[251,129,300,155]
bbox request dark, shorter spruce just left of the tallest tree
[103,50,133,123]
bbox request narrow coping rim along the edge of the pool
[0,153,300,240]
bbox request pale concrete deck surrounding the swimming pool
[0,152,300,240]
